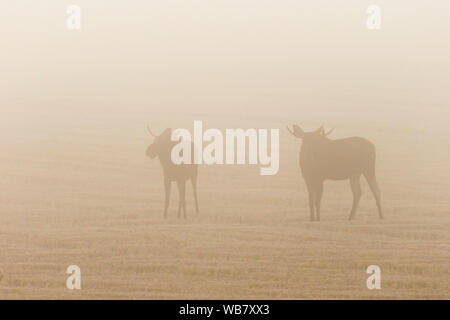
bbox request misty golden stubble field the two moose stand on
[0,110,450,299]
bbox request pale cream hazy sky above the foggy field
[0,0,450,124]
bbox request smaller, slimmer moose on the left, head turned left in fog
[146,127,199,219]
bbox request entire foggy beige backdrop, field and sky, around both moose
[0,0,450,299]
